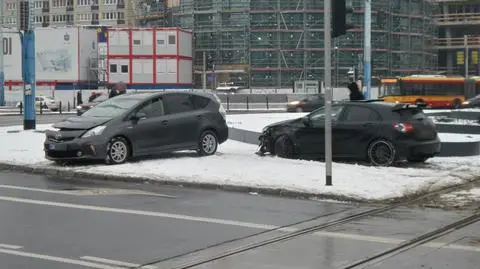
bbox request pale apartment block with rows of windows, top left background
[4,0,135,27]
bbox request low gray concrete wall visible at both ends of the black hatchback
[229,128,480,157]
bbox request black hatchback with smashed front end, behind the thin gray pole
[258,101,441,166]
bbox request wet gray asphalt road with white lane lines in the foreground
[0,171,480,269]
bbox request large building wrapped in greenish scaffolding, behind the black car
[171,0,437,88]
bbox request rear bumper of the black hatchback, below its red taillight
[399,138,442,158]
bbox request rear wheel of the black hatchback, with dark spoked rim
[367,139,397,166]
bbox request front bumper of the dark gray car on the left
[43,138,107,161]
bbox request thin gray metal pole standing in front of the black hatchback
[323,0,335,186]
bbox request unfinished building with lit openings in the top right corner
[432,0,480,75]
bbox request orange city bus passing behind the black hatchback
[379,75,467,108]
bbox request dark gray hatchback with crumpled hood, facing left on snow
[44,91,228,164]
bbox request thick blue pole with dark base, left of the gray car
[18,0,36,130]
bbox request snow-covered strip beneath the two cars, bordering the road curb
[0,122,480,199]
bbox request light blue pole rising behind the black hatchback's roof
[363,0,372,99]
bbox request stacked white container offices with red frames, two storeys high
[107,28,192,89]
